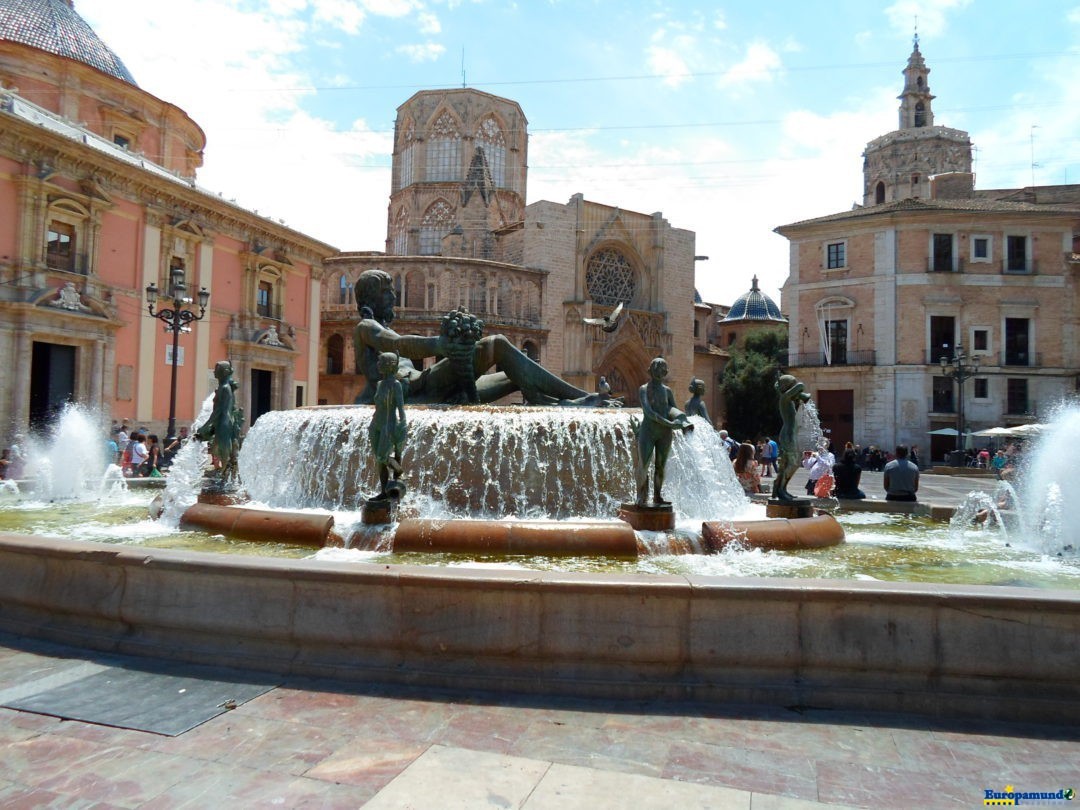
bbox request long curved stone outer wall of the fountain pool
[0,535,1080,724]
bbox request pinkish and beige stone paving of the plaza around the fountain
[0,476,1080,810]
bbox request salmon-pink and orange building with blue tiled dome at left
[0,0,334,441]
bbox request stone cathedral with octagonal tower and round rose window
[320,89,694,404]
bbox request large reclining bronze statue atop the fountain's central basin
[352,270,621,405]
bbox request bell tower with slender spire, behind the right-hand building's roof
[863,37,971,205]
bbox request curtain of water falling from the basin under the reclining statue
[239,406,746,519]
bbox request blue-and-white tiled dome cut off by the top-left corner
[0,0,138,86]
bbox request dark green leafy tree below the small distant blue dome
[720,328,787,442]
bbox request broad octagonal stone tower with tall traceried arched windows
[387,87,528,259]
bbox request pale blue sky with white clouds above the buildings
[75,0,1080,311]
